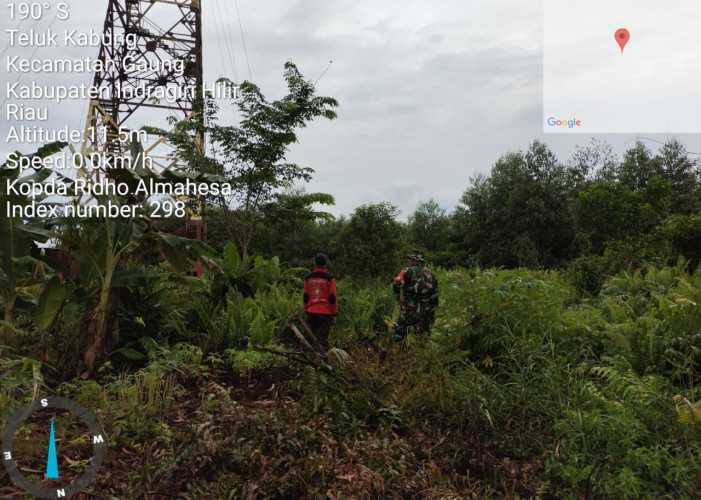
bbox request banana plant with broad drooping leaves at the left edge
[0,135,219,374]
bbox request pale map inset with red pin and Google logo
[543,0,701,134]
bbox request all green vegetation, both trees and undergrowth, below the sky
[0,65,701,499]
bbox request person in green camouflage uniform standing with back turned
[392,252,438,339]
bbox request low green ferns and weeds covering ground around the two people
[2,261,701,498]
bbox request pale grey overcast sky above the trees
[0,0,701,216]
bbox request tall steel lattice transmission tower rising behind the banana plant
[82,0,206,239]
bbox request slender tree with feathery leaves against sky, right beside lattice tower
[163,62,338,256]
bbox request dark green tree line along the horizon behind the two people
[200,140,701,292]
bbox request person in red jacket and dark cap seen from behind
[304,254,338,350]
